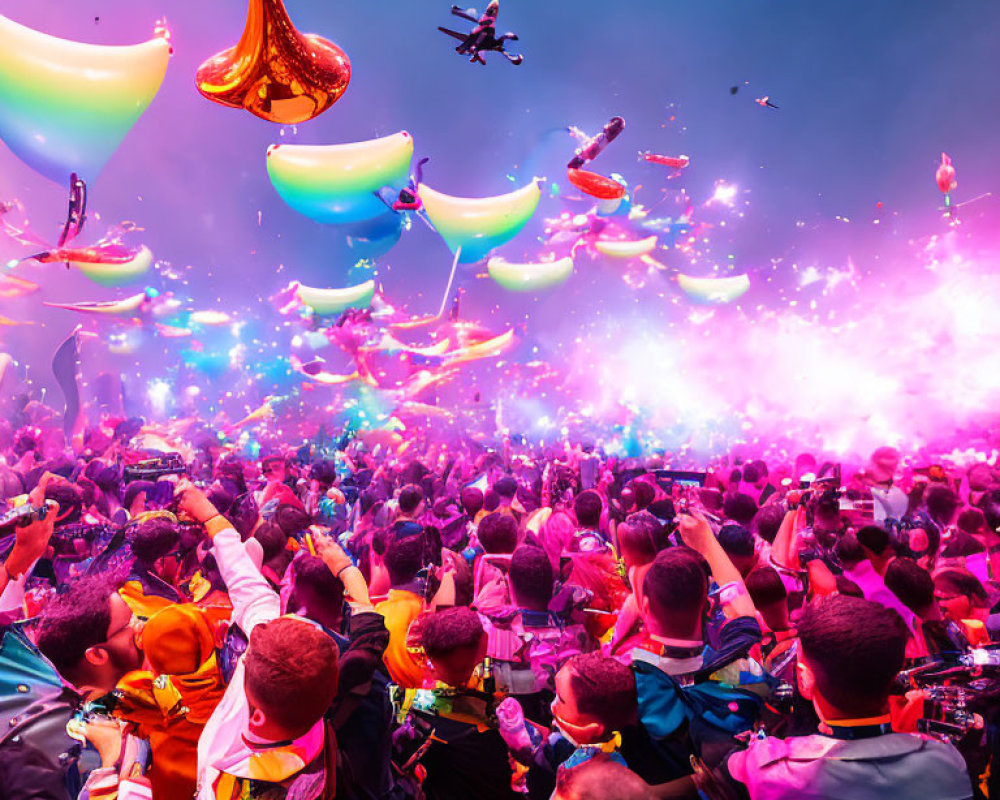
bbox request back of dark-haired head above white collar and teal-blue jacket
[640,547,708,639]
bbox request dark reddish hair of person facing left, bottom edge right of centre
[564,652,637,732]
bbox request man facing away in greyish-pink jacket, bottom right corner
[726,595,972,800]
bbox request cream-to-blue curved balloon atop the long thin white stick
[417,179,542,264]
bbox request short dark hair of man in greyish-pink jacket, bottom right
[798,595,909,717]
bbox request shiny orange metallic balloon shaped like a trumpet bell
[195,0,351,125]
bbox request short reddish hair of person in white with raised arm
[244,617,339,738]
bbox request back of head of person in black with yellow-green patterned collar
[420,606,487,687]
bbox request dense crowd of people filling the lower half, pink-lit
[0,410,1000,800]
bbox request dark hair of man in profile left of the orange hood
[37,576,115,681]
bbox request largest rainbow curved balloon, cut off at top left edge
[0,16,170,186]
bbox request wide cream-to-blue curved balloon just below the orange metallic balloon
[267,131,413,225]
